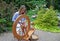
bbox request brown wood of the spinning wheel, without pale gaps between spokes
[12,15,34,40]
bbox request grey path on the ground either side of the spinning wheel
[0,30,60,41]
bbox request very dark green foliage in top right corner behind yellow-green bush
[46,0,60,11]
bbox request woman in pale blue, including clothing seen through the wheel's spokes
[12,5,26,35]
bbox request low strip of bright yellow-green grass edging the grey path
[34,25,60,33]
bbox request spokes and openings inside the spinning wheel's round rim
[17,20,28,36]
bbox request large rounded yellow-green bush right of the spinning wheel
[34,8,58,29]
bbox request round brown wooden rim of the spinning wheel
[12,15,30,39]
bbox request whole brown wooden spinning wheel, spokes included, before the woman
[12,15,34,40]
